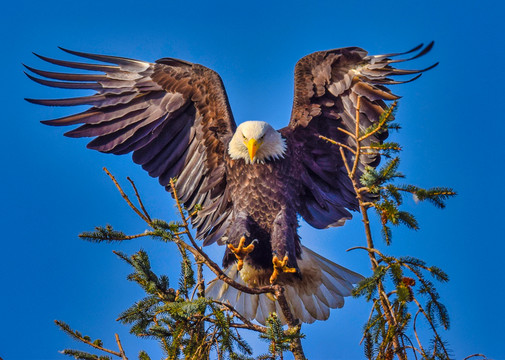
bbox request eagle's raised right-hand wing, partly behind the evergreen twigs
[281,43,437,228]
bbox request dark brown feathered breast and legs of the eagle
[223,136,301,270]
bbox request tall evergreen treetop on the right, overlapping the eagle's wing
[326,98,456,360]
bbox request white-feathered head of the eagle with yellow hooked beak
[228,121,286,164]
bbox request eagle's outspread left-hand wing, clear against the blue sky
[27,50,236,242]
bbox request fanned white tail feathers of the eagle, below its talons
[206,246,363,325]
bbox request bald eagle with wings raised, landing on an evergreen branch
[27,43,436,324]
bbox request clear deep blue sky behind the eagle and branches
[0,0,505,360]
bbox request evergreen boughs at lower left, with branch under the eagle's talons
[56,176,305,360]
